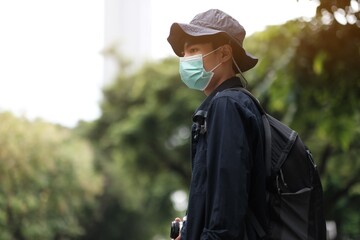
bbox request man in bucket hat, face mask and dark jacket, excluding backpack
[168,9,267,240]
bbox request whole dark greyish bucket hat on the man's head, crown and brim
[167,9,258,72]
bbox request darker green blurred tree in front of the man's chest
[83,59,204,239]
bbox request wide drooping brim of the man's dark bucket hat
[167,23,258,72]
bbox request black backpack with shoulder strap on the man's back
[236,88,326,240]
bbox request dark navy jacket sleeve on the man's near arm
[201,97,252,240]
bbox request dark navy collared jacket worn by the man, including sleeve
[182,77,266,240]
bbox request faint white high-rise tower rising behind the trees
[104,0,151,83]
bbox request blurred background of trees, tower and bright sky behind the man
[0,0,360,240]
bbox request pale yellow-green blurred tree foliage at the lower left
[0,113,101,240]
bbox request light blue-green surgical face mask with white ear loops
[179,47,221,91]
